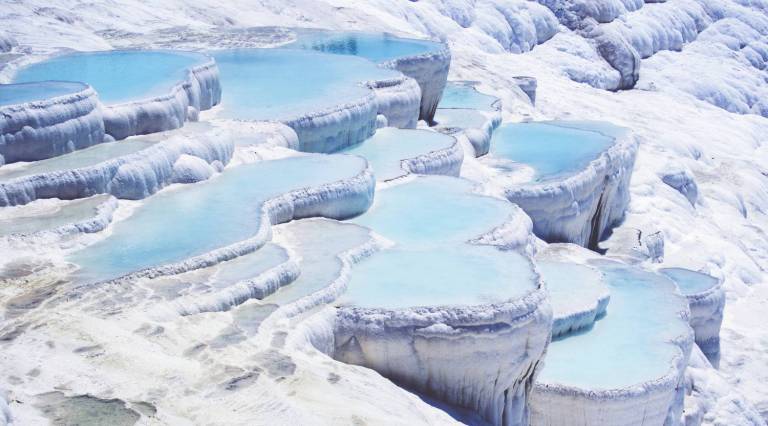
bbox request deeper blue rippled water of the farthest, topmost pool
[286,29,442,62]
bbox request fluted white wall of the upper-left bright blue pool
[103,55,221,140]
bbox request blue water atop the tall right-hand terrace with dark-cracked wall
[490,122,615,180]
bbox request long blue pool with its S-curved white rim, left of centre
[68,155,375,291]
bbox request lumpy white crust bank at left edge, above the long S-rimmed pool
[0,133,234,207]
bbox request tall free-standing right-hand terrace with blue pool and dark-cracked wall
[480,121,638,249]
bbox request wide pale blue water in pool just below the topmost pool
[211,49,398,120]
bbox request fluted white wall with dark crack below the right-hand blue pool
[505,130,638,249]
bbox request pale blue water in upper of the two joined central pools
[352,176,512,248]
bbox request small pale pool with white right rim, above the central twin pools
[341,127,464,181]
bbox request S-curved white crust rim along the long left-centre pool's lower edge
[67,163,376,292]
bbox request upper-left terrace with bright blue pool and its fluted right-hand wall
[12,50,221,140]
